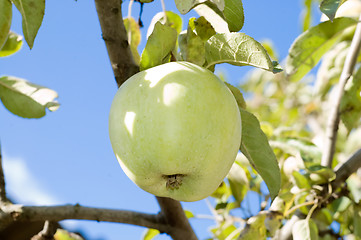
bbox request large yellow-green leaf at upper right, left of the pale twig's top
[285,18,357,81]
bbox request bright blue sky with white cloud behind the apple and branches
[0,0,319,240]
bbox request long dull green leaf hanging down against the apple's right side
[240,108,281,199]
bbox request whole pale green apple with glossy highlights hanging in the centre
[109,62,242,202]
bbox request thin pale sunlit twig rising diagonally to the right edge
[321,15,361,167]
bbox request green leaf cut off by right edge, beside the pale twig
[340,68,361,132]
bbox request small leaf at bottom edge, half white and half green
[292,219,318,240]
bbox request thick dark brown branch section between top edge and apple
[95,0,139,87]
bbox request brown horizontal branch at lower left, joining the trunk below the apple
[0,204,169,232]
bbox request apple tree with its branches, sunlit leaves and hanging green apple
[0,0,361,240]
